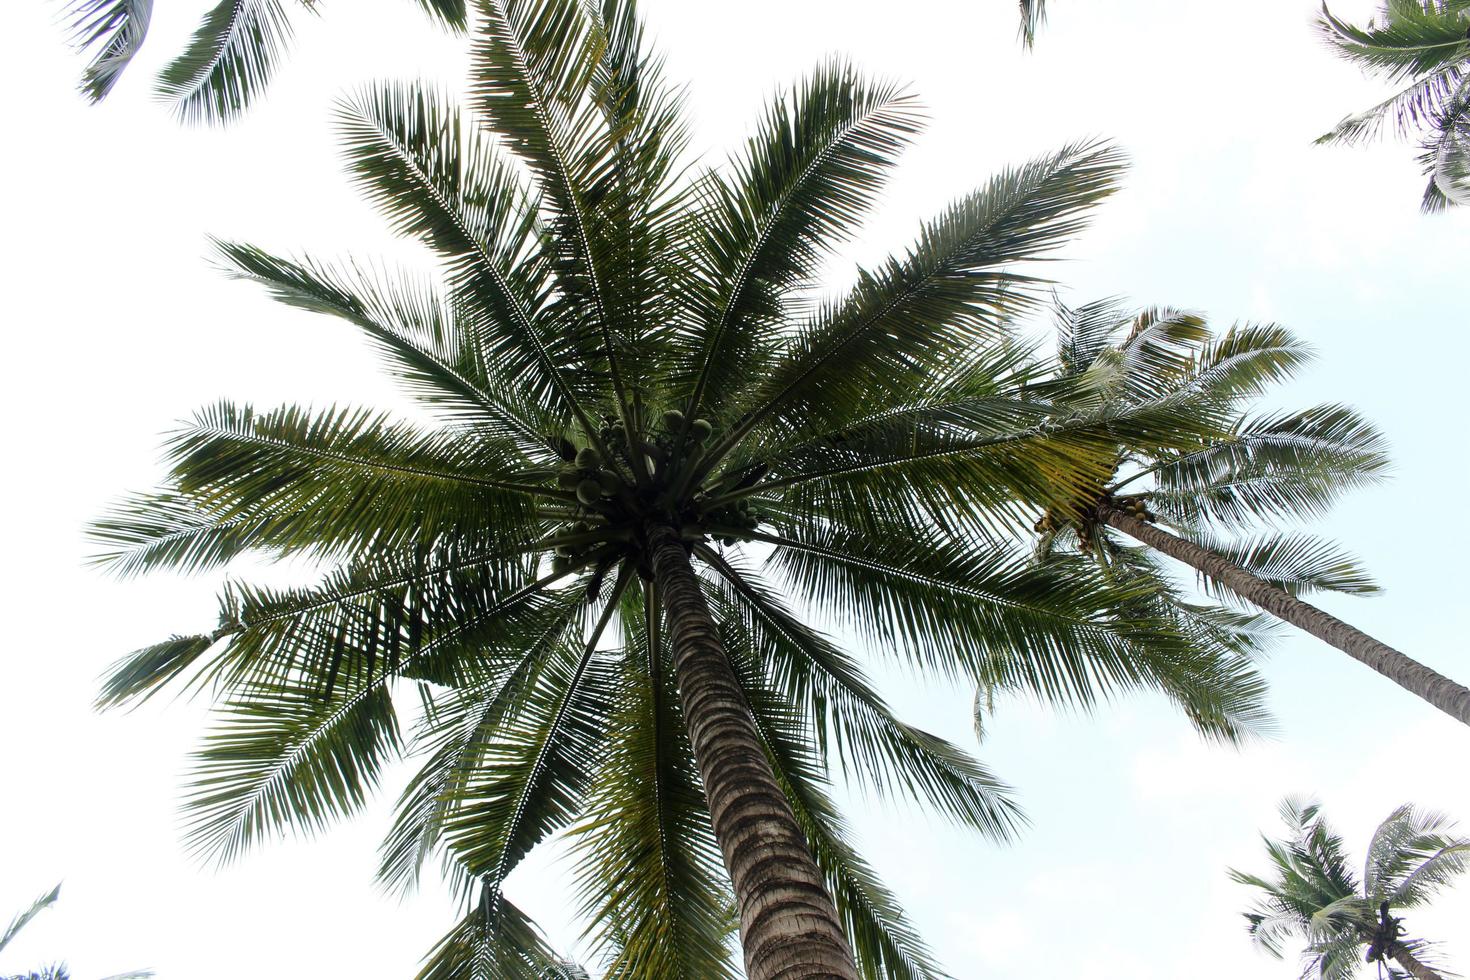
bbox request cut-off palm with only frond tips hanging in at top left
[66,0,467,123]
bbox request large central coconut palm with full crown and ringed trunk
[96,0,1260,980]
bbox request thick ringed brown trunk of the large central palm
[648,526,857,980]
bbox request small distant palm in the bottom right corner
[1230,799,1470,980]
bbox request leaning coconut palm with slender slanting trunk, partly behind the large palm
[1011,300,1470,724]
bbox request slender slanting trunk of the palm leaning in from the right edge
[1100,507,1470,724]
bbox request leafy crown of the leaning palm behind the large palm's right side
[1033,300,1388,625]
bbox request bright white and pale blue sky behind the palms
[0,0,1470,980]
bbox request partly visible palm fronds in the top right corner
[1317,0,1470,212]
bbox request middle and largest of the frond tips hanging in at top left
[159,0,291,123]
